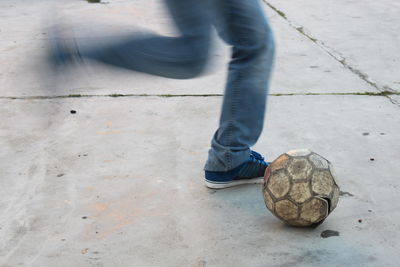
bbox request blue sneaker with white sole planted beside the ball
[205,151,268,189]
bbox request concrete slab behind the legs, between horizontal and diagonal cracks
[0,0,374,96]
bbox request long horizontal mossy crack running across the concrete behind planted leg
[0,91,400,100]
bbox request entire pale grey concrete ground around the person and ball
[0,0,400,267]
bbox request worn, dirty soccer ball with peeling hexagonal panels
[263,149,340,226]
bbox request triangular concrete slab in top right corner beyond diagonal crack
[265,0,400,91]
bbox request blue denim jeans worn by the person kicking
[83,0,275,171]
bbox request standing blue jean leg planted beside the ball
[204,0,275,171]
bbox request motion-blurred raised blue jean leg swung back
[78,0,211,79]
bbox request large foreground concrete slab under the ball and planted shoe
[0,96,400,266]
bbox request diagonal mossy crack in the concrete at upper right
[263,0,396,101]
